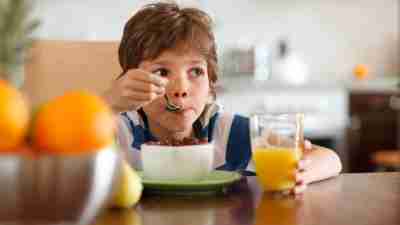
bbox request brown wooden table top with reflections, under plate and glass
[94,173,400,225]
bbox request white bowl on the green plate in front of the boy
[141,144,214,180]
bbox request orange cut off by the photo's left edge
[0,80,29,152]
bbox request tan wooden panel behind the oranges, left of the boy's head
[23,40,121,105]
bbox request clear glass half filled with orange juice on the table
[250,113,304,191]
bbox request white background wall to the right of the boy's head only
[209,0,400,81]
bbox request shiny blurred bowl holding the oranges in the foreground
[0,147,121,224]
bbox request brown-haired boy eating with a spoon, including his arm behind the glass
[104,3,341,193]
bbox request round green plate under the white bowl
[138,170,242,195]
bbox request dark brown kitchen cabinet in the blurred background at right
[347,91,399,172]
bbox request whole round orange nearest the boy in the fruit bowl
[32,91,115,154]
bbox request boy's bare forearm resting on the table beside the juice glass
[305,145,342,183]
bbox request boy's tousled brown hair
[119,3,218,94]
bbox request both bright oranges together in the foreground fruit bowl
[0,80,115,155]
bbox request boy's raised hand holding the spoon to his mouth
[104,69,168,112]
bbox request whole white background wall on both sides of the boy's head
[35,0,400,79]
